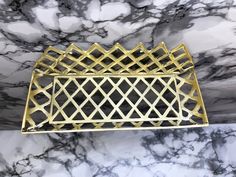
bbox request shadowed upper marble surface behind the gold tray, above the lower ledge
[0,0,236,129]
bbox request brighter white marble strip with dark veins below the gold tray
[0,124,236,177]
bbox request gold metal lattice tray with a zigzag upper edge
[22,42,208,133]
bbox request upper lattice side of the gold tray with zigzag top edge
[35,43,193,75]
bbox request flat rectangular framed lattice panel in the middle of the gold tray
[50,76,180,124]
